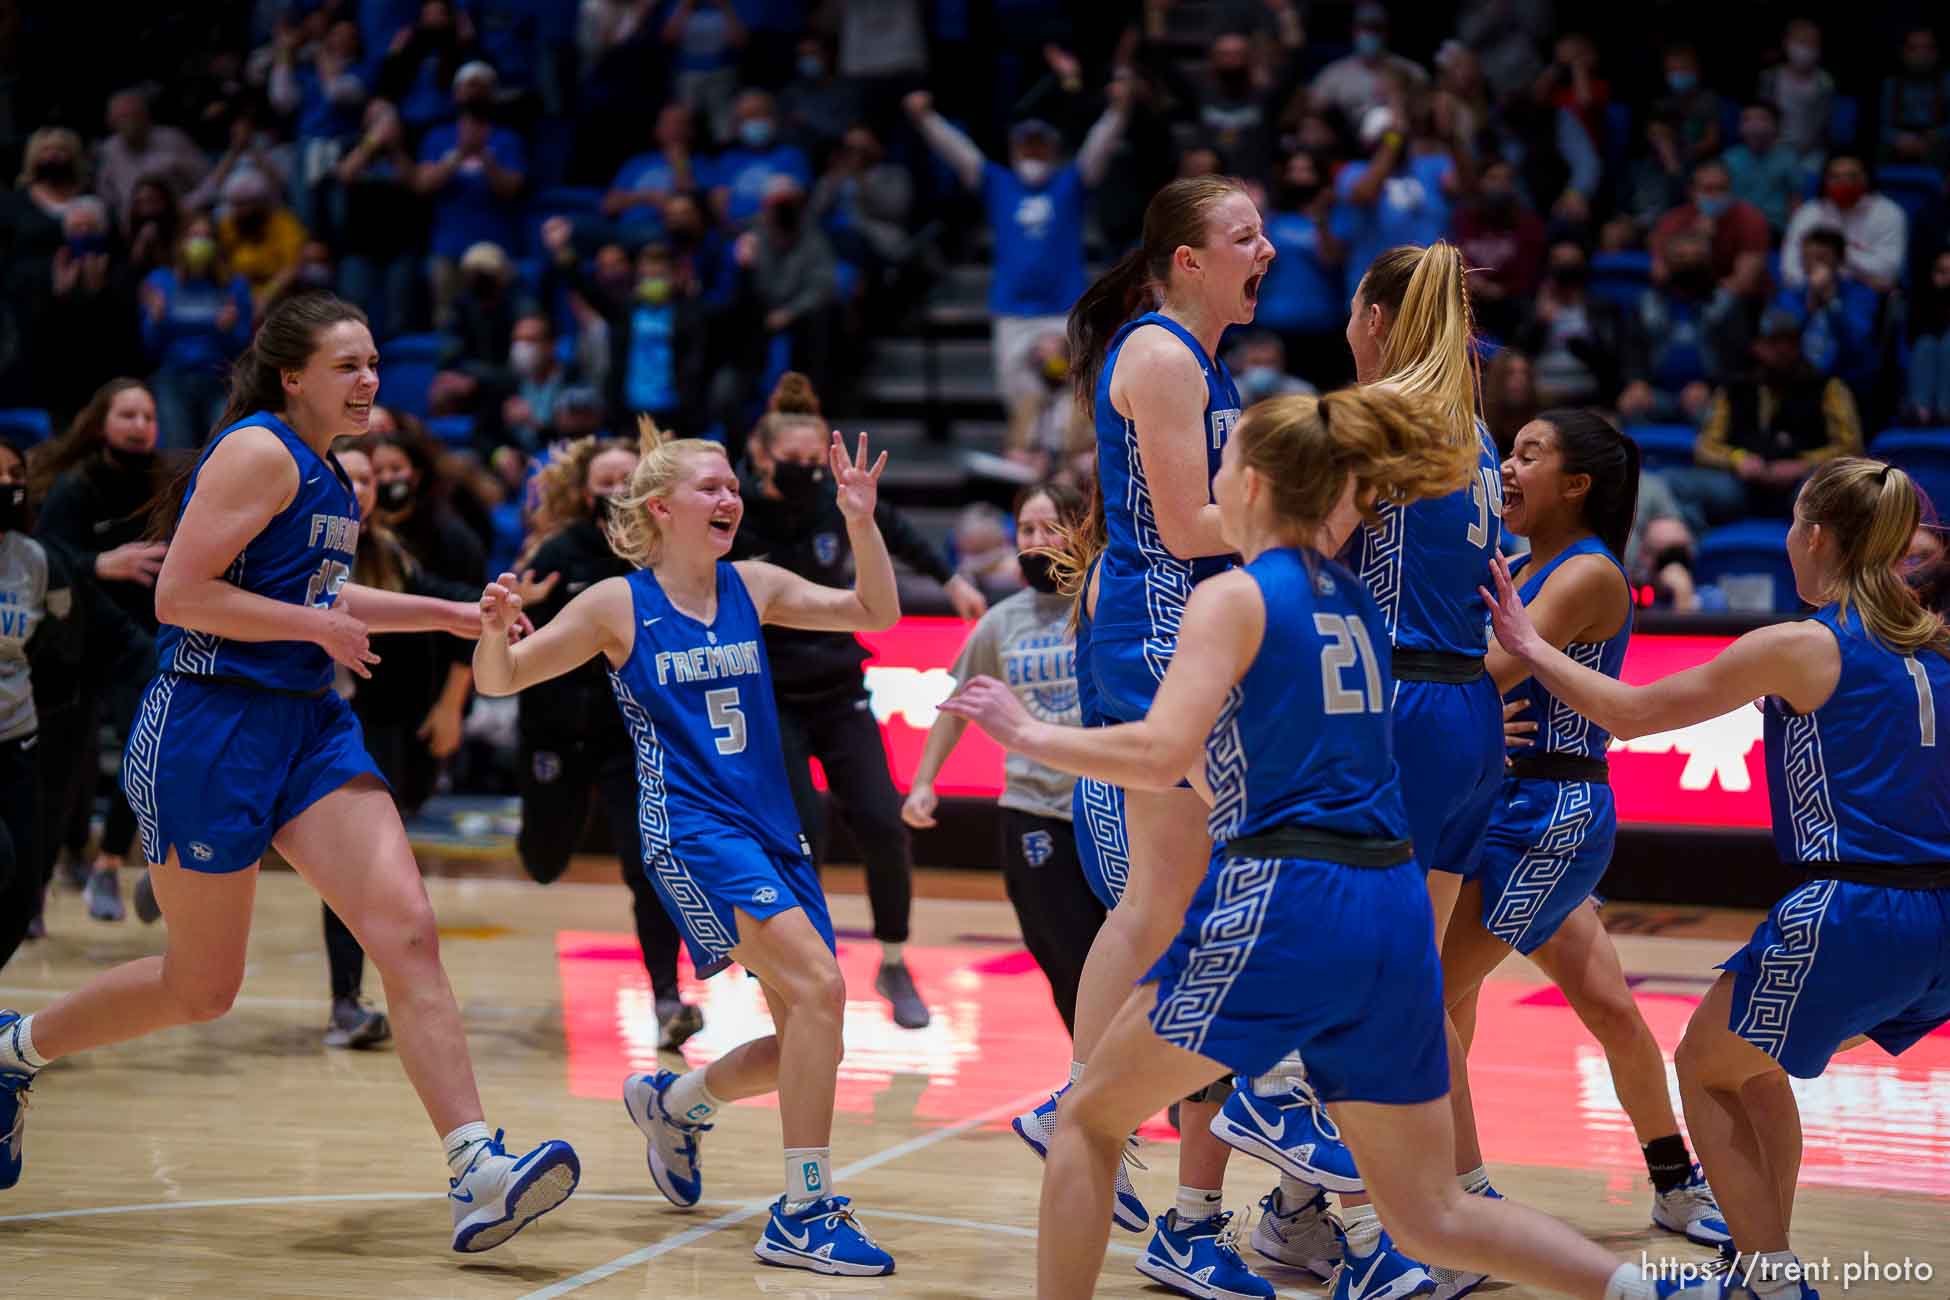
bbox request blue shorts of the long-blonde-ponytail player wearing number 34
[1394,676,1503,875]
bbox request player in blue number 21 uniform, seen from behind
[942,388,1702,1300]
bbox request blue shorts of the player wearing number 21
[1145,854,1449,1105]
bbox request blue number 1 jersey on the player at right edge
[1763,604,1950,867]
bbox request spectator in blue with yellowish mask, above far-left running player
[140,216,252,446]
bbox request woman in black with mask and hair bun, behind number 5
[731,374,987,1029]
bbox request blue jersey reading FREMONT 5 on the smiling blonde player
[608,561,805,863]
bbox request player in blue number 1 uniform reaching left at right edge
[1484,458,1950,1300]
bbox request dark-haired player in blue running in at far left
[0,294,581,1251]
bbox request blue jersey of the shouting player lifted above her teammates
[1094,312,1238,637]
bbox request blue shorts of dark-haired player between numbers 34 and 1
[1468,776,1619,957]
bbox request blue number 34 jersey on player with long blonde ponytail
[1349,423,1503,655]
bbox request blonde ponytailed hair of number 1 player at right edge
[1794,456,1950,657]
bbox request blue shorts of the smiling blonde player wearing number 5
[644,826,839,978]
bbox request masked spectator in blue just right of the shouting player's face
[1254,150,1353,386]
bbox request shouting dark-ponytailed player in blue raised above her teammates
[1016,175,1273,1296]
